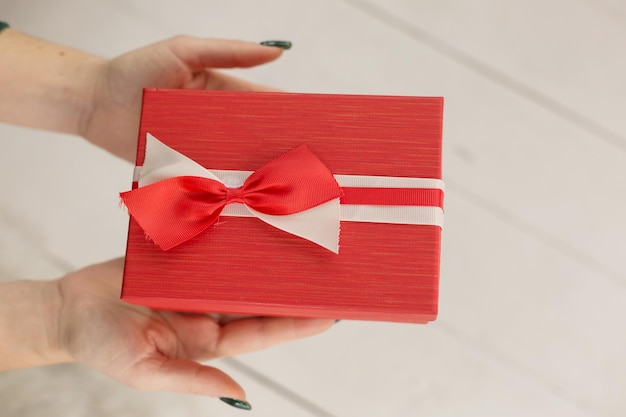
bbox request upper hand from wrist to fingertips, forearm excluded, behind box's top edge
[80,36,282,162]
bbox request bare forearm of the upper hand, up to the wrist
[0,29,103,138]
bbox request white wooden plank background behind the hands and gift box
[0,0,626,417]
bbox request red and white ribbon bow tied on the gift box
[120,135,342,252]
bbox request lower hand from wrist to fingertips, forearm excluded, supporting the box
[57,259,334,400]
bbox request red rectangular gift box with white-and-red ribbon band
[122,90,443,323]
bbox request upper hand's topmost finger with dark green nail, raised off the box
[164,36,283,71]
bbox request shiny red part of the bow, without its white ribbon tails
[120,145,342,250]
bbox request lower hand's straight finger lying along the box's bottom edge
[215,317,335,357]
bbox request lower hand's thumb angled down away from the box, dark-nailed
[122,353,246,400]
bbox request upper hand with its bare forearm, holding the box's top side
[0,29,288,161]
